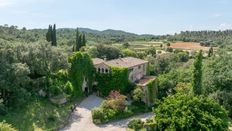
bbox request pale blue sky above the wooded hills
[0,0,232,35]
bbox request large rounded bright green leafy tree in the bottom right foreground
[154,94,228,130]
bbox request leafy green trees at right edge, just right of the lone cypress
[202,51,232,117]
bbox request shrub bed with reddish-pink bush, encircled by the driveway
[91,91,151,124]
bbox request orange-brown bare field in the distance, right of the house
[170,42,209,51]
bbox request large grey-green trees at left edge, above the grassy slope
[0,43,68,107]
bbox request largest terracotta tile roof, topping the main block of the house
[106,57,148,68]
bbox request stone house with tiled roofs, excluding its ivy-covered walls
[92,57,157,105]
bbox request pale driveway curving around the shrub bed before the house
[61,95,152,131]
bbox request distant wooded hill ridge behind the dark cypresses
[0,26,156,45]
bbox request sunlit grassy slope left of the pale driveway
[0,96,80,131]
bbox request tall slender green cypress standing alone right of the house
[192,50,203,95]
